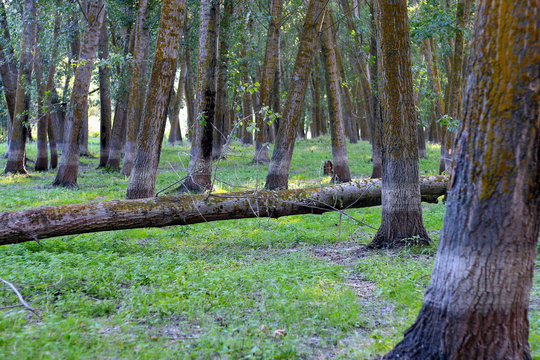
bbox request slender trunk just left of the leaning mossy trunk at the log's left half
[122,0,149,176]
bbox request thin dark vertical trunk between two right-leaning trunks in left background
[98,15,112,167]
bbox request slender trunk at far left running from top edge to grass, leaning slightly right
[4,0,37,174]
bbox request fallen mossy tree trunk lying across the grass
[0,176,448,245]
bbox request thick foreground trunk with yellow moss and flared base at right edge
[386,0,540,359]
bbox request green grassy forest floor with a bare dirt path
[0,137,540,359]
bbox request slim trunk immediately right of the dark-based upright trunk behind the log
[212,0,234,159]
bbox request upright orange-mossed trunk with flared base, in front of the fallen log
[370,0,430,248]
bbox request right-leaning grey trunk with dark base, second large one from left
[53,0,105,187]
